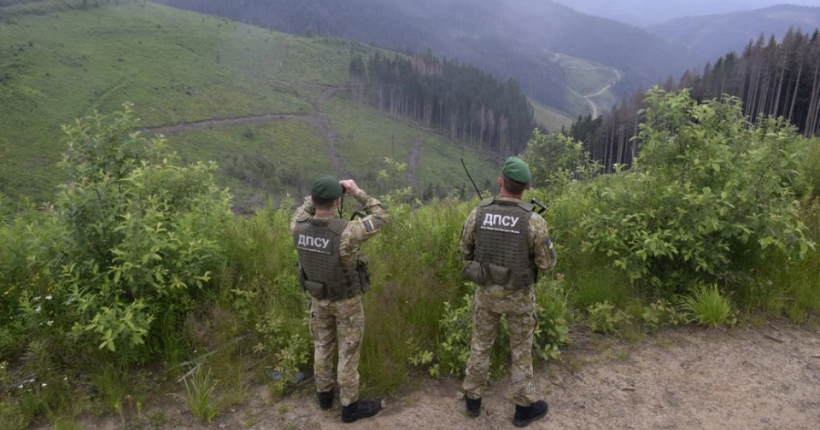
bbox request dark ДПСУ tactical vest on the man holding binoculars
[293,217,363,301]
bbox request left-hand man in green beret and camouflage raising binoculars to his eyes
[290,175,387,423]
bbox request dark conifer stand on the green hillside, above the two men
[349,50,535,155]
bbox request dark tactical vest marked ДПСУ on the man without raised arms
[474,199,538,289]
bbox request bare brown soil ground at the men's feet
[78,323,820,430]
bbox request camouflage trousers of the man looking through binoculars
[310,296,364,406]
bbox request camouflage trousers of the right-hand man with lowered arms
[462,285,538,406]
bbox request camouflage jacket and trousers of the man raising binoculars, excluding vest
[290,191,387,406]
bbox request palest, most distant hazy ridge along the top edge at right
[556,0,820,26]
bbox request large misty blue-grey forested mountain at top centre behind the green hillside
[158,0,692,110]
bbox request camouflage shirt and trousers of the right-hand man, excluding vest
[461,198,555,406]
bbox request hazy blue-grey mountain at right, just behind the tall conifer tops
[648,2,820,64]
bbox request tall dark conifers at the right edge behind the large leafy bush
[569,31,820,170]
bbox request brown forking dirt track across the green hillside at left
[144,84,348,177]
